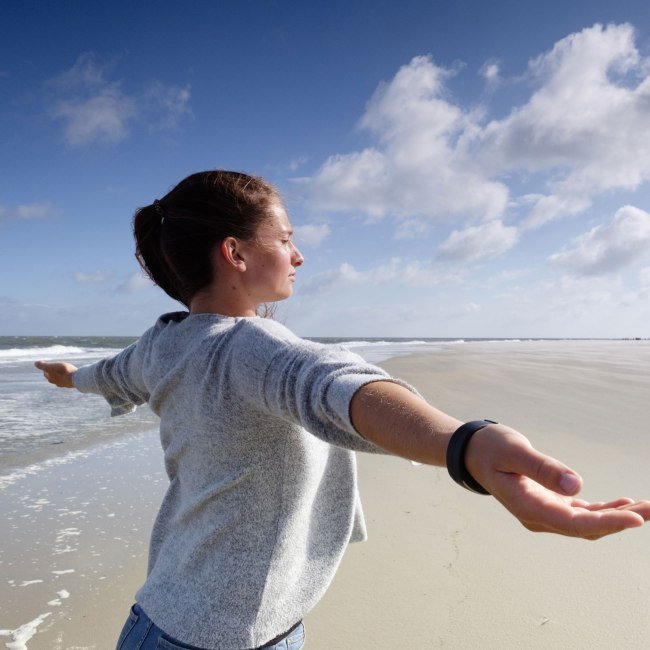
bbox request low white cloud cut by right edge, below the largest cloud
[550,205,650,275]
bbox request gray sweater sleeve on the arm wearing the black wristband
[230,322,417,453]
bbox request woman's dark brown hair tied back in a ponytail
[133,170,281,307]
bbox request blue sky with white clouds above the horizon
[0,0,650,338]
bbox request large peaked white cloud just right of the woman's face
[305,56,508,224]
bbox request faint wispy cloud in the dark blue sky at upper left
[48,53,191,146]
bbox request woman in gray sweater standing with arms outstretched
[36,171,650,649]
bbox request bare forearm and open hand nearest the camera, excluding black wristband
[350,381,650,539]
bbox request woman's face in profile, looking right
[240,204,304,305]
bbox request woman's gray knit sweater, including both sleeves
[74,312,404,650]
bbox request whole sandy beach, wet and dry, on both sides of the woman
[0,341,650,650]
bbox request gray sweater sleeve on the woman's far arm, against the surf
[72,339,149,416]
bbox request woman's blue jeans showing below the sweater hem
[116,603,305,650]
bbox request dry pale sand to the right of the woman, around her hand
[307,342,650,650]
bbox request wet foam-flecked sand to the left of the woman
[0,432,167,650]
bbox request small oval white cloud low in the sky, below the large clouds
[438,220,519,262]
